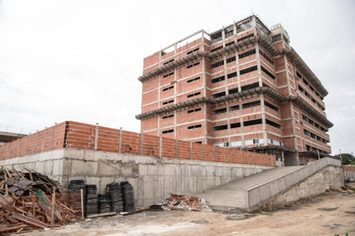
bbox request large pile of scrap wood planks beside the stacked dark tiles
[0,168,81,234]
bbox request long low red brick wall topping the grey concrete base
[0,121,275,166]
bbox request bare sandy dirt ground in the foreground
[13,186,355,236]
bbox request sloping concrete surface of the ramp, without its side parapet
[197,166,302,210]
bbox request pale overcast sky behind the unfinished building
[0,0,355,153]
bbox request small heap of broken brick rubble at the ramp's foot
[164,194,211,211]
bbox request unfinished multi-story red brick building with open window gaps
[136,15,333,165]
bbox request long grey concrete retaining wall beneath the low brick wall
[0,148,271,207]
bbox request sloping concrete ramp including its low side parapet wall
[197,158,341,210]
